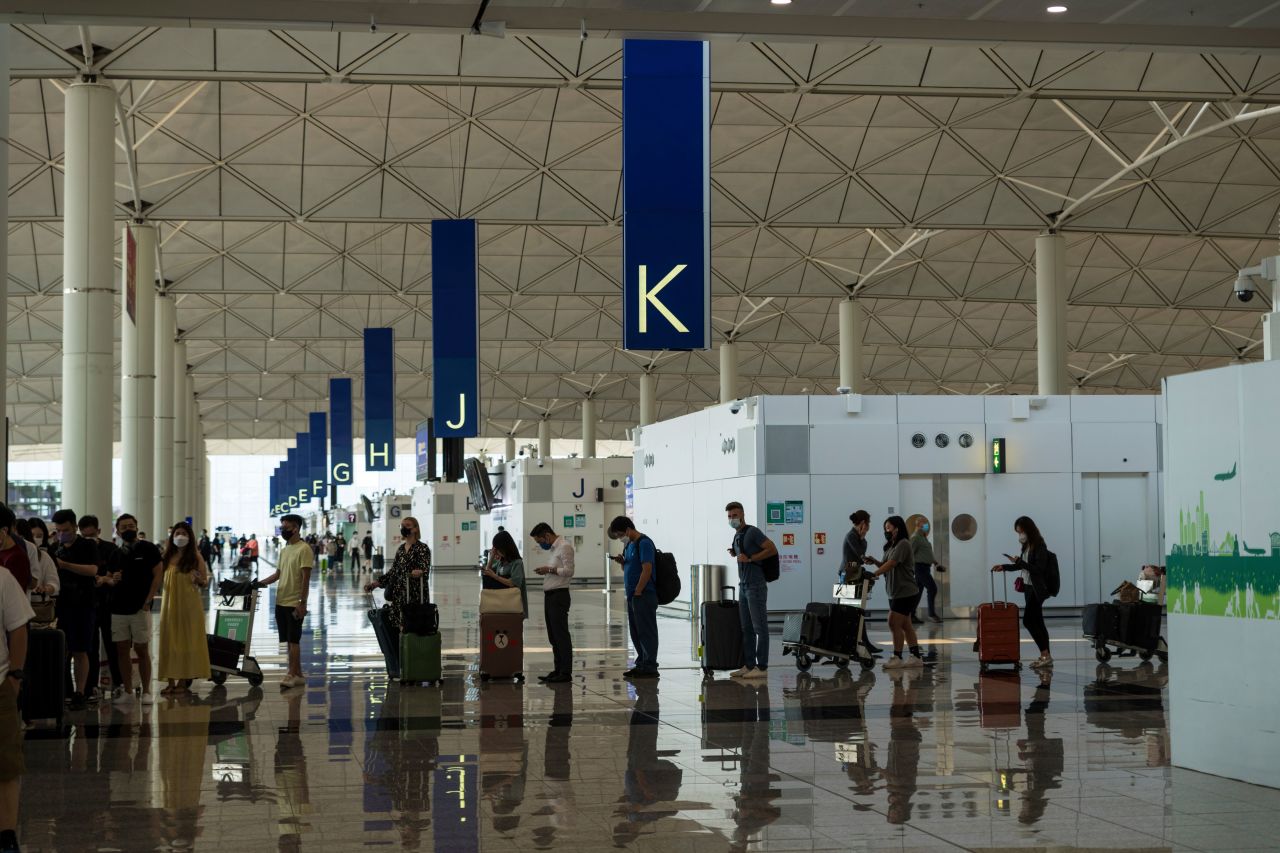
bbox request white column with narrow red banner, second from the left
[120,225,156,530]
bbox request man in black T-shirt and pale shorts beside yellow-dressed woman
[111,512,163,704]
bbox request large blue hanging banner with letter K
[622,38,712,350]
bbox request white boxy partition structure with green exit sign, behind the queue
[635,394,1160,615]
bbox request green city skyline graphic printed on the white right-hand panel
[1166,479,1280,619]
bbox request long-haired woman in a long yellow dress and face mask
[155,521,210,695]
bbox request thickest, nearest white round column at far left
[63,83,115,520]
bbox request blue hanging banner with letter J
[431,219,480,438]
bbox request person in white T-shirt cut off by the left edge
[0,545,36,853]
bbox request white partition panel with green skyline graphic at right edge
[1165,361,1280,786]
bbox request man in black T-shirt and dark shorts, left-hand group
[54,510,99,711]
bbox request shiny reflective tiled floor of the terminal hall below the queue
[20,560,1280,853]
